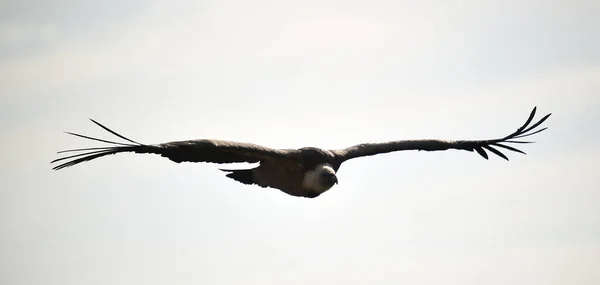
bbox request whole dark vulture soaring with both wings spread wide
[51,107,551,198]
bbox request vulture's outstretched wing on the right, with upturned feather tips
[332,107,551,163]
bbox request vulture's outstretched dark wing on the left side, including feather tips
[50,119,299,170]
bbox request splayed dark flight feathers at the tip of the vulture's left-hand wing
[50,119,160,170]
